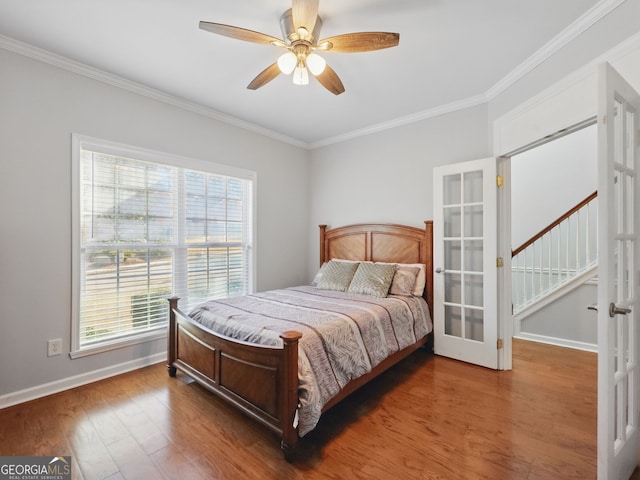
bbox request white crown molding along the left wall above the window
[0,35,309,149]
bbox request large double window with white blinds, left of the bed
[72,135,255,357]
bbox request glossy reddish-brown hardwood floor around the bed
[0,340,597,480]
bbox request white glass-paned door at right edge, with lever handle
[598,64,640,480]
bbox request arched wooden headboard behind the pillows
[320,220,433,315]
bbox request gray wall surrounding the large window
[0,49,310,396]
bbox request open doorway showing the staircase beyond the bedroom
[509,121,598,351]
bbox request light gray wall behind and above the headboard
[309,105,489,276]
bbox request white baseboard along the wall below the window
[0,352,167,409]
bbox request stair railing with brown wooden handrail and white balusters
[511,192,598,320]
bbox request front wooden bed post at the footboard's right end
[280,331,302,462]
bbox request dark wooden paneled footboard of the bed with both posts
[167,297,302,460]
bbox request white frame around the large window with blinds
[69,133,257,359]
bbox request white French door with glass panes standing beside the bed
[433,158,498,369]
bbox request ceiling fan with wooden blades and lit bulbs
[200,0,400,95]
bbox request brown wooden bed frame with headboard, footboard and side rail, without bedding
[167,221,433,461]
